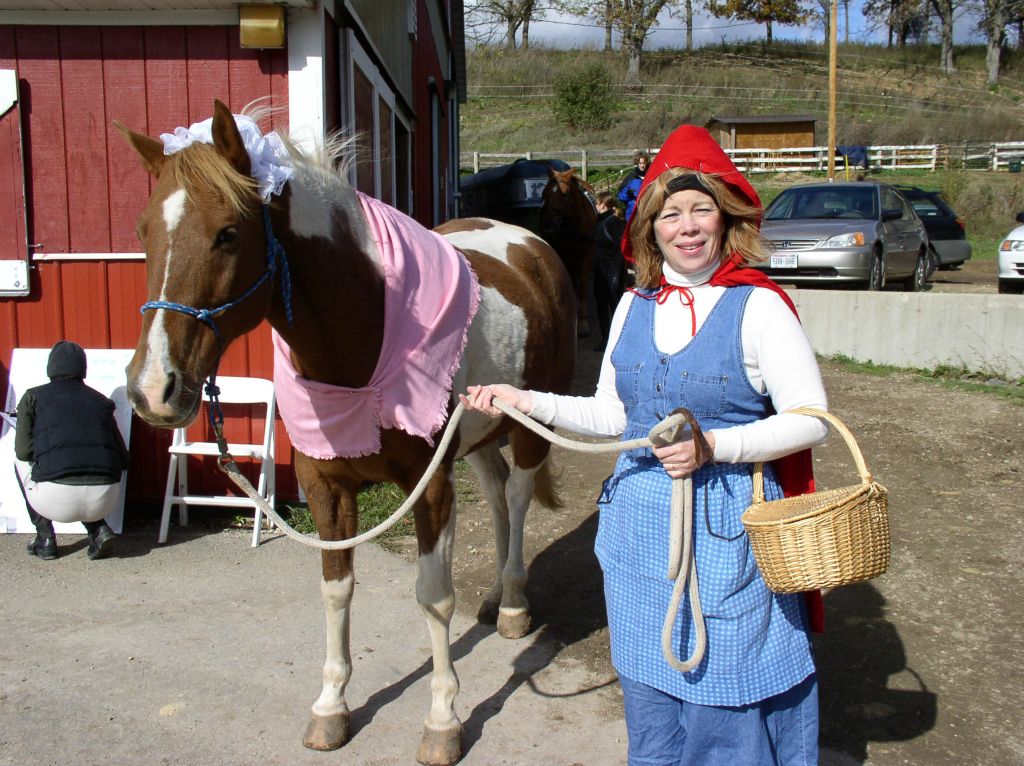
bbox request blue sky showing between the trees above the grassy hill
[516,6,980,50]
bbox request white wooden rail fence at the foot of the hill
[460,141,1024,178]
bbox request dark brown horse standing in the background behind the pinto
[539,167,597,338]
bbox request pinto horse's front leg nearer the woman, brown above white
[415,462,462,766]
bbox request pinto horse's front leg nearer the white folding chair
[296,457,358,750]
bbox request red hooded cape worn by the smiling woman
[623,125,824,633]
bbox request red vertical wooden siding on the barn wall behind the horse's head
[0,26,296,502]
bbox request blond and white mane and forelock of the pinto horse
[173,99,355,216]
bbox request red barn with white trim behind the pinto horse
[0,0,465,503]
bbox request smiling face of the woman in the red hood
[654,188,725,273]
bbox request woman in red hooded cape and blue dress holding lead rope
[460,125,826,766]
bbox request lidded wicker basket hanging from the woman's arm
[742,408,890,593]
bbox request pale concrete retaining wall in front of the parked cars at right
[788,290,1024,378]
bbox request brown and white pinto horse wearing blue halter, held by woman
[115,100,575,764]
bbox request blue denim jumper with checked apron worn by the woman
[595,286,814,706]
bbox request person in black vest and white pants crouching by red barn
[14,340,128,560]
